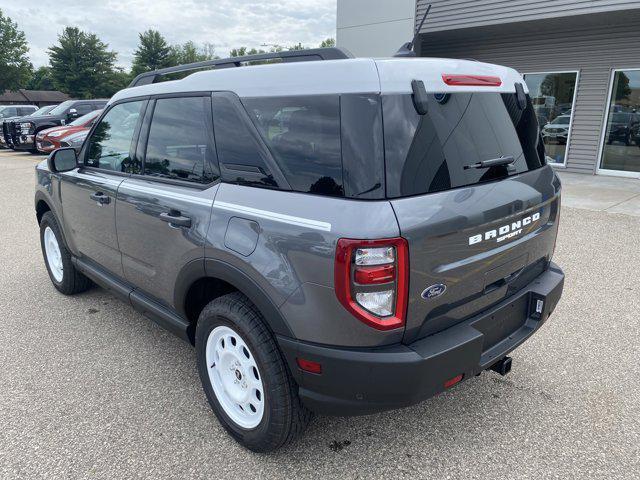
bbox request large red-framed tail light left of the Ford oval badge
[334,238,409,330]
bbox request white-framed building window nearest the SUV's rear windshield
[524,72,578,165]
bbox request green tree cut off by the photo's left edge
[0,10,33,93]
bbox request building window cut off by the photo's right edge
[600,70,640,176]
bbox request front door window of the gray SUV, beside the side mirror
[85,101,144,173]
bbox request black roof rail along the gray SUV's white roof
[128,47,353,88]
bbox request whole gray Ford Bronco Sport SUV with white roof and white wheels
[35,49,564,451]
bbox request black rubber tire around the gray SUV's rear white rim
[195,292,312,452]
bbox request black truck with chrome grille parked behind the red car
[10,99,107,152]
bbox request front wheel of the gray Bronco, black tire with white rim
[40,212,93,295]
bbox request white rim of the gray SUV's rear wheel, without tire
[205,326,264,429]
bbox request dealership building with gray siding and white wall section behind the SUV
[337,0,640,178]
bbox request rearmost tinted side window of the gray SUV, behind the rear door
[242,95,344,196]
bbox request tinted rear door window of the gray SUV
[144,97,218,184]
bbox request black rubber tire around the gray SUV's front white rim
[40,212,93,295]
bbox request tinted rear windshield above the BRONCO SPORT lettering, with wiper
[382,92,544,198]
